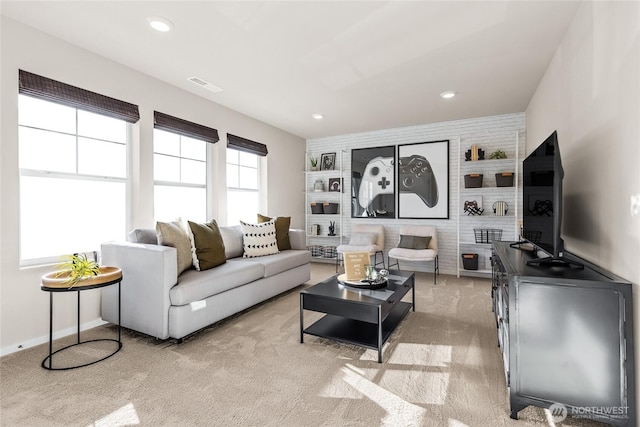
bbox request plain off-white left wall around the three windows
[0,16,305,357]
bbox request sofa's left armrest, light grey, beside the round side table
[102,242,178,339]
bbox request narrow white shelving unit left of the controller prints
[305,152,344,263]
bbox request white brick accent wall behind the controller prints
[306,113,526,274]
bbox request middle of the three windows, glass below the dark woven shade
[153,128,207,222]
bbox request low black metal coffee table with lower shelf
[300,270,416,363]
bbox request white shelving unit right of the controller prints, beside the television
[455,132,521,278]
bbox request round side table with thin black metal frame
[40,267,122,371]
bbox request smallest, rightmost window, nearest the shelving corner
[227,148,260,225]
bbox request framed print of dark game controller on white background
[398,140,449,219]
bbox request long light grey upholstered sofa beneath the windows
[102,226,311,340]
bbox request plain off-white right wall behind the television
[526,2,640,414]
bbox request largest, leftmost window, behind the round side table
[18,95,128,265]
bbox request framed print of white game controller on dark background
[351,145,396,218]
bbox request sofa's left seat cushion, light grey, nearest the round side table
[169,258,264,305]
